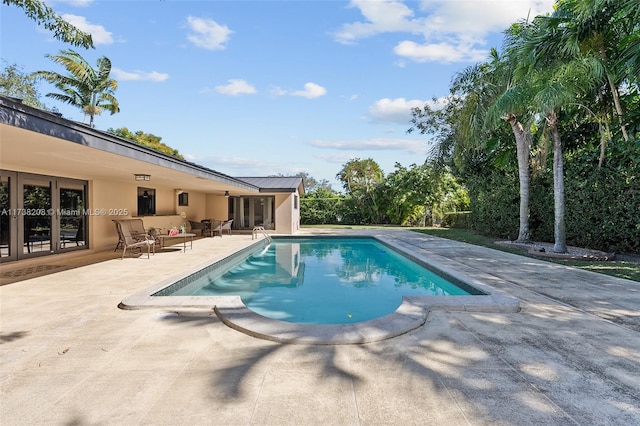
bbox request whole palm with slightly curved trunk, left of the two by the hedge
[409,49,532,242]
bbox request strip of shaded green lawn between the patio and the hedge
[303,225,640,282]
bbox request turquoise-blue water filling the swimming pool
[156,238,478,324]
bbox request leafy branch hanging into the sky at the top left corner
[2,0,93,49]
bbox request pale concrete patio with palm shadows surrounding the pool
[0,230,640,426]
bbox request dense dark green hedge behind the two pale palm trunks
[468,142,640,253]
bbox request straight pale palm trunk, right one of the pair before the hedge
[547,111,567,253]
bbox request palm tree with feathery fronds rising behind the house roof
[34,49,120,127]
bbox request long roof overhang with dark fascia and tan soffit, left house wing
[0,96,260,195]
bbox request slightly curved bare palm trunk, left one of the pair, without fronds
[506,114,531,242]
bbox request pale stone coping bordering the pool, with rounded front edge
[118,235,520,345]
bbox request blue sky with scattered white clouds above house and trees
[0,0,553,190]
